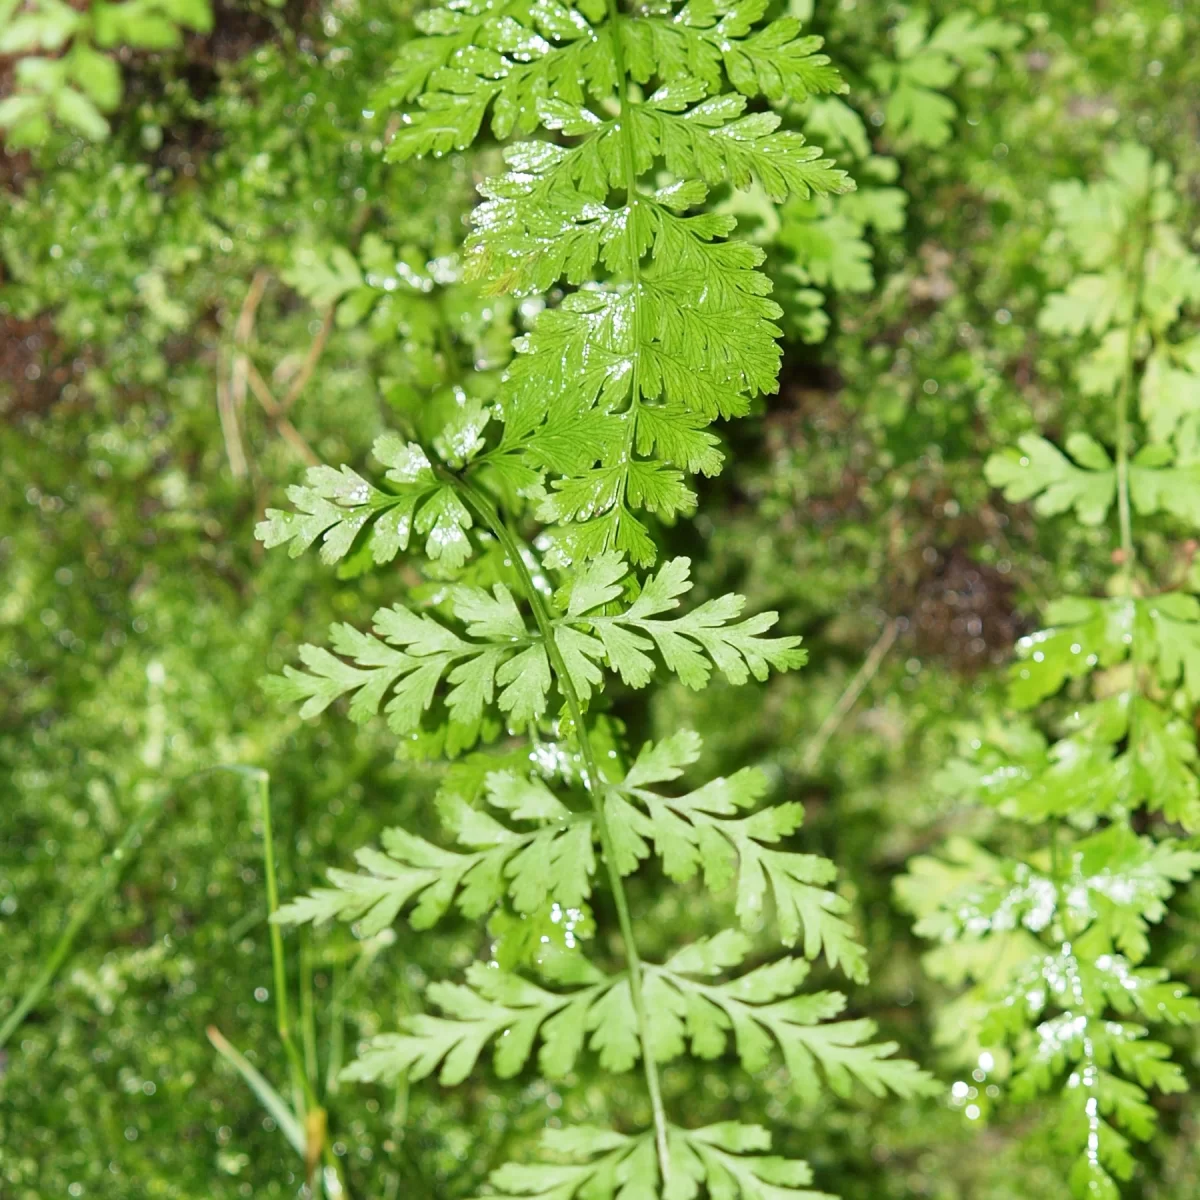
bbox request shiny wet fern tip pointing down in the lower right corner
[901,824,1200,1196]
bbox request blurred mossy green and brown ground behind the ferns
[0,0,1200,1200]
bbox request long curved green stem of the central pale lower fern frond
[449,476,671,1190]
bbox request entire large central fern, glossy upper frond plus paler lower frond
[259,0,930,1200]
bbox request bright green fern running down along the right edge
[902,145,1200,1200]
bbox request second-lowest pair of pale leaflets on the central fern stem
[347,931,936,1102]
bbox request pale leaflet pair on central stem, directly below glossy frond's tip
[268,553,806,745]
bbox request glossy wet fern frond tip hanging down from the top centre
[374,0,852,565]
